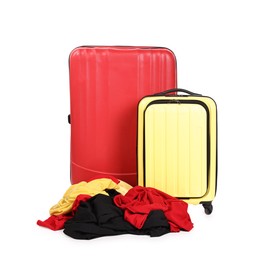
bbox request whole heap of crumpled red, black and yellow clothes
[37,176,193,239]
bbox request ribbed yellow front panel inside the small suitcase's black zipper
[144,103,207,198]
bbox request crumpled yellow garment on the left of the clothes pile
[50,178,132,215]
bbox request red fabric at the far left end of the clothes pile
[37,194,91,231]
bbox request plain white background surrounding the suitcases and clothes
[0,0,260,259]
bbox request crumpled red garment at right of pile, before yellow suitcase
[114,186,193,232]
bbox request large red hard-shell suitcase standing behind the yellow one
[69,46,177,186]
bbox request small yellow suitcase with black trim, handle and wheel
[137,89,217,214]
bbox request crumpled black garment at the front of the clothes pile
[63,194,170,239]
